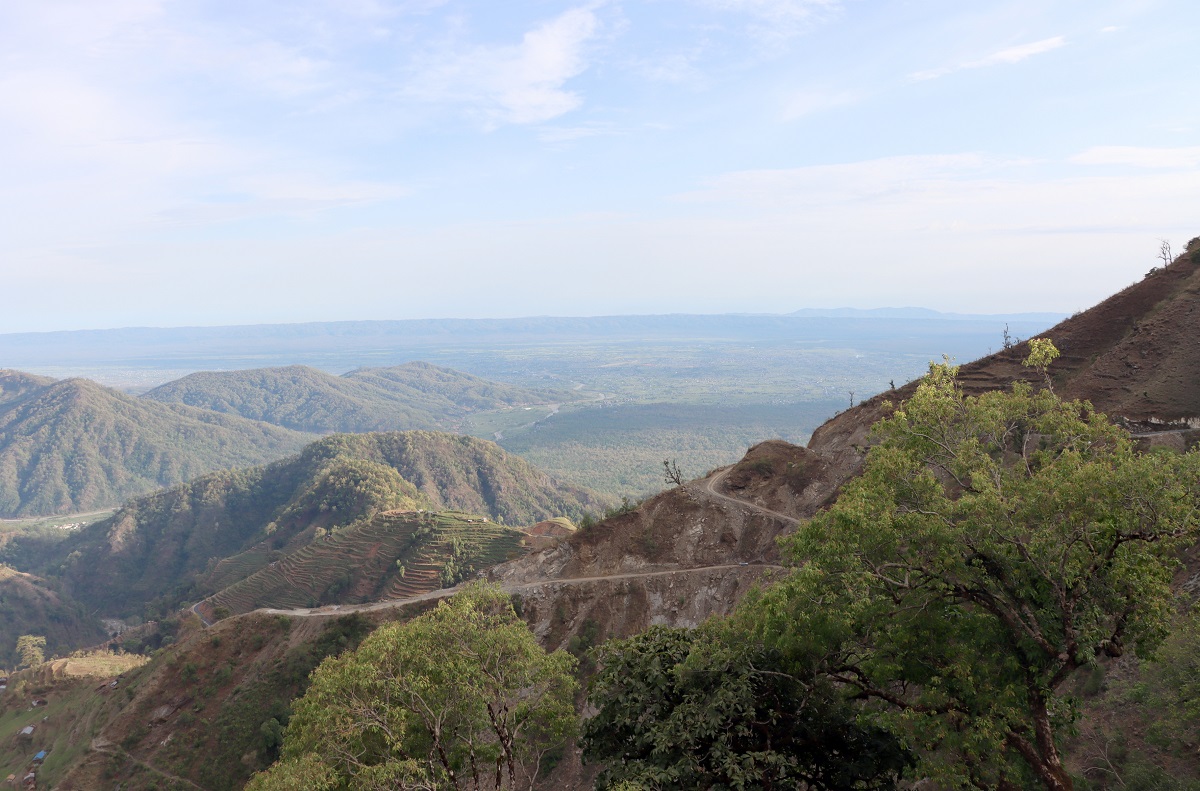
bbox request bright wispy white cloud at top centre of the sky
[402,6,601,126]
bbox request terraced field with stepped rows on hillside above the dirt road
[197,511,524,621]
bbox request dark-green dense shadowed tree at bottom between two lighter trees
[582,621,910,791]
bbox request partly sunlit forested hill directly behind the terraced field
[44,431,606,616]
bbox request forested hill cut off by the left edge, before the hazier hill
[0,371,311,517]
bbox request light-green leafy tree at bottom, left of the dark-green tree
[247,583,576,791]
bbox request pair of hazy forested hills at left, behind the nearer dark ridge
[0,362,571,517]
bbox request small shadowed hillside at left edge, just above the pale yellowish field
[0,565,107,667]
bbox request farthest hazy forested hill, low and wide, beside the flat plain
[143,362,570,433]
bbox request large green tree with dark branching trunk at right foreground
[739,352,1200,791]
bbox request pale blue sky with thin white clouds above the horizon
[0,0,1200,332]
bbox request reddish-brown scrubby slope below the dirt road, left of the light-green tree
[56,612,403,791]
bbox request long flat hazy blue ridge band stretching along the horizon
[0,307,1064,386]
